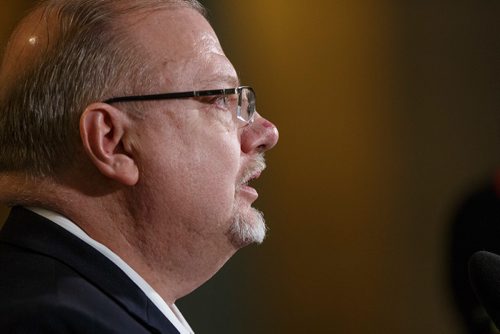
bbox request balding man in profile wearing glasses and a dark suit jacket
[0,0,278,333]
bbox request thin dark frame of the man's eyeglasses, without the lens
[102,86,256,124]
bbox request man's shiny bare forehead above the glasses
[130,8,238,90]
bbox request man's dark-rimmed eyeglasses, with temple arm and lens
[103,86,255,124]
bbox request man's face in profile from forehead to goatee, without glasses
[125,9,278,258]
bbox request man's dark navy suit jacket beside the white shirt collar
[0,207,178,334]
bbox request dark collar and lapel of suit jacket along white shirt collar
[0,207,179,334]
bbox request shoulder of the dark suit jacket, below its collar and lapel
[0,243,150,333]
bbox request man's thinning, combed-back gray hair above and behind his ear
[0,0,205,176]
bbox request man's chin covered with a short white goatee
[228,207,267,248]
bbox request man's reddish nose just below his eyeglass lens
[241,114,279,154]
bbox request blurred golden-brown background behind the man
[0,0,500,334]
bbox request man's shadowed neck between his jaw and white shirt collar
[0,173,234,305]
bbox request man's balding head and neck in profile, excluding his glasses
[0,0,278,300]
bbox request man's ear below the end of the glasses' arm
[80,103,139,186]
